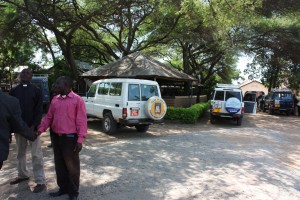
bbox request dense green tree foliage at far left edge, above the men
[0,4,36,86]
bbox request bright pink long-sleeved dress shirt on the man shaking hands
[38,91,87,143]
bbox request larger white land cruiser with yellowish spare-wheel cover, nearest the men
[83,78,167,134]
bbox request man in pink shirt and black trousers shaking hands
[38,76,87,200]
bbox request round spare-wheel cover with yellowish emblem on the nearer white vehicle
[145,96,167,120]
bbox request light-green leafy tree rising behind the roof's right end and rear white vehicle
[156,0,260,94]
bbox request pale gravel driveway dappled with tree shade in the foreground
[0,113,300,200]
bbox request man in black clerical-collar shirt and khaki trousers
[10,69,46,193]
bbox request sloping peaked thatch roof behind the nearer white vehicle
[81,52,196,81]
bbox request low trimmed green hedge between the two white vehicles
[165,103,210,124]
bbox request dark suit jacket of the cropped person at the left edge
[0,90,37,162]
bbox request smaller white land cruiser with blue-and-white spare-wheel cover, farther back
[210,84,256,126]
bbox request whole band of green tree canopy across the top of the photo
[0,0,300,94]
